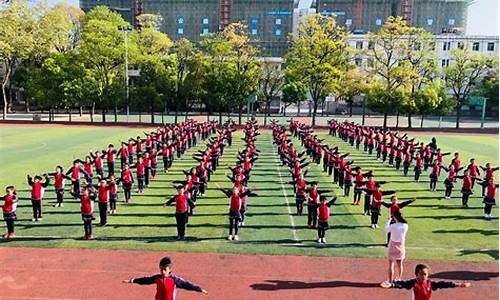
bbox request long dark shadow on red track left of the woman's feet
[250,280,380,291]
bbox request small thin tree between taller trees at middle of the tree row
[258,62,283,125]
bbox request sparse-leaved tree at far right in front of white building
[444,47,497,128]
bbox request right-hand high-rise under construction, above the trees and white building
[312,0,469,34]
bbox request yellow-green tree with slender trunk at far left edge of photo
[0,0,36,120]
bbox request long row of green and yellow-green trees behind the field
[0,0,498,127]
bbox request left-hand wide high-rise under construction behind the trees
[80,0,298,57]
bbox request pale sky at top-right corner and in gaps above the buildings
[49,0,499,35]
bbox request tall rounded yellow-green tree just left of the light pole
[79,6,130,122]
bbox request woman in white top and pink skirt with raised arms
[384,211,408,282]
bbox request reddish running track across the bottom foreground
[0,247,498,300]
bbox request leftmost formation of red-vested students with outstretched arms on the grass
[2,120,217,240]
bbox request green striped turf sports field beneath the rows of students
[0,126,499,261]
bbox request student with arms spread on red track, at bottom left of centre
[123,256,208,300]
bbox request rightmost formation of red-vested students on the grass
[329,120,499,220]
